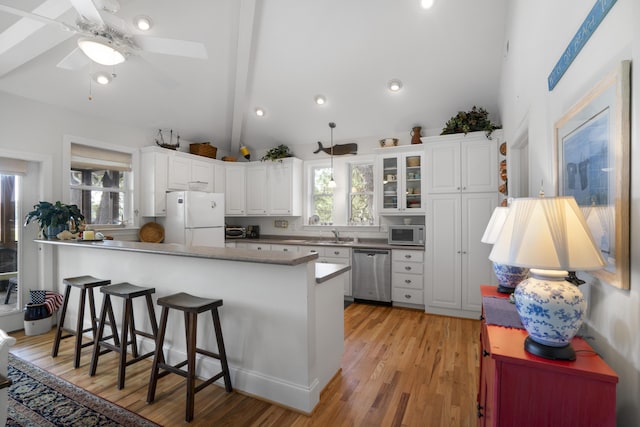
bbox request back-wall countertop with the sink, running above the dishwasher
[226,235,424,251]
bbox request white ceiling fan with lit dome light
[0,0,207,70]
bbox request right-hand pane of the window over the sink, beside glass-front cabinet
[349,163,374,225]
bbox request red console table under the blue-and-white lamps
[478,286,618,427]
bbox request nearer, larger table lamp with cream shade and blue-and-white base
[489,196,605,360]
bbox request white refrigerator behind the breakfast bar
[164,191,224,248]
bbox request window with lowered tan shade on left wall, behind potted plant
[69,142,132,225]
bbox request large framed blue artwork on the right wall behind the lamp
[555,61,631,289]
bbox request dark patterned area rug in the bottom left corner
[7,353,158,427]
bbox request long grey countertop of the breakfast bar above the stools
[36,239,318,265]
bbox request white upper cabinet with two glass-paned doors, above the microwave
[376,147,425,215]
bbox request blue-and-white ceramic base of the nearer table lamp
[514,269,587,360]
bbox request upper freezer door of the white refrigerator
[184,191,224,228]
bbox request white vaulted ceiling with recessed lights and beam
[0,0,507,154]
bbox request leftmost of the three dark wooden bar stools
[51,276,111,368]
